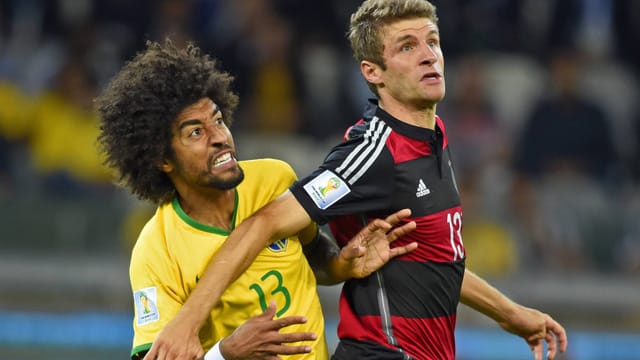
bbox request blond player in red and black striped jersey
[148,0,567,360]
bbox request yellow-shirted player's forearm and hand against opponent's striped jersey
[305,209,418,285]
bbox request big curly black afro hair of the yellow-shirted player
[96,39,238,203]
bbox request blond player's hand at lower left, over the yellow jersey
[143,311,204,360]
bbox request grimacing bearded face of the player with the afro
[162,98,244,190]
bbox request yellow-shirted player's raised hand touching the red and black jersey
[339,209,418,278]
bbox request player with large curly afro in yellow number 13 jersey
[97,41,417,359]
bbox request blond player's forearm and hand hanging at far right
[460,270,568,360]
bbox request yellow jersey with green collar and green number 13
[129,159,328,359]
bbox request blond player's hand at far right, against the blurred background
[498,305,568,360]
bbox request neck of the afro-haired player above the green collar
[178,189,235,231]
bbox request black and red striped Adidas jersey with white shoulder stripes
[290,99,465,360]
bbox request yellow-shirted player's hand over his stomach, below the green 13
[220,302,317,360]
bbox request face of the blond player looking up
[378,18,445,108]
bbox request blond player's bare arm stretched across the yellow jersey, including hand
[145,191,311,359]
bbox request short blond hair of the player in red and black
[348,0,438,95]
